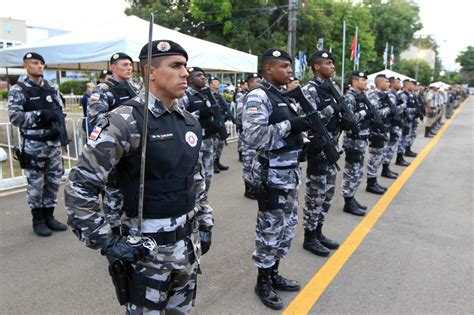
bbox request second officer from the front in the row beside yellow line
[303,50,341,257]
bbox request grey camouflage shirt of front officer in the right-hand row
[242,80,301,189]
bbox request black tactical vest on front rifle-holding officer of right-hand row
[261,82,303,152]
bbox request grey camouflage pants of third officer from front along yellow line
[341,137,368,197]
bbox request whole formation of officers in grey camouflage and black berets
[8,40,466,314]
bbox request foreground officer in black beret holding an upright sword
[65,40,212,314]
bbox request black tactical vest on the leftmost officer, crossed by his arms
[17,81,61,141]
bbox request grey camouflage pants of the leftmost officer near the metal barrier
[23,139,64,209]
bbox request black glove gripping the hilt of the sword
[100,235,148,263]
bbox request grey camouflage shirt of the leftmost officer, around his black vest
[8,76,64,146]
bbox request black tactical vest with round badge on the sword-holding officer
[117,100,202,219]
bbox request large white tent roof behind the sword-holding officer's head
[0,16,258,72]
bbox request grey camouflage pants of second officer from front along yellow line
[303,158,337,231]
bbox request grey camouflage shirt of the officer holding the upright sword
[65,90,213,252]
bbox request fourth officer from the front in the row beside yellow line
[365,74,393,195]
